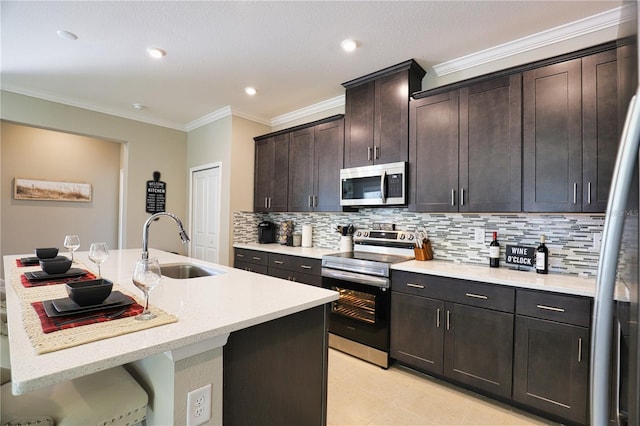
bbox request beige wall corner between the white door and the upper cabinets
[187,116,270,265]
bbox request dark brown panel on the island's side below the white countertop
[223,306,328,426]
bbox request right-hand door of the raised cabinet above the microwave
[373,72,409,164]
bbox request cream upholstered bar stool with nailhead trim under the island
[0,367,149,426]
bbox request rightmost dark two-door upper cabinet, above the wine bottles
[522,50,619,213]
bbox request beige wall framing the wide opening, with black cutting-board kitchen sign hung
[0,91,188,262]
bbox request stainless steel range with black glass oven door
[322,230,415,368]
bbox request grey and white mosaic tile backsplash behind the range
[233,208,604,276]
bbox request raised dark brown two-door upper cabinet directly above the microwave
[343,59,425,167]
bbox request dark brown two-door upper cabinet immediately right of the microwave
[409,73,522,212]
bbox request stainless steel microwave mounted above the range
[340,162,407,207]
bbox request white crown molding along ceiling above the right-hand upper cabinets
[433,5,631,77]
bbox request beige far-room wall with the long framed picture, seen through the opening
[1,122,122,253]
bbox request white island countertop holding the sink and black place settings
[4,249,337,394]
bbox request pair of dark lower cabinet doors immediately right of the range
[391,292,513,398]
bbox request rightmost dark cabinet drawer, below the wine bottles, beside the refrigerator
[516,289,591,327]
